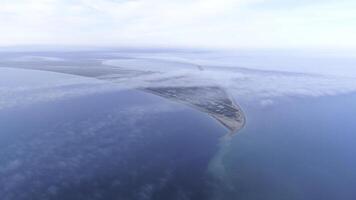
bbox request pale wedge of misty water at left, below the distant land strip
[0,68,126,111]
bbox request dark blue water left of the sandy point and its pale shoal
[0,91,226,200]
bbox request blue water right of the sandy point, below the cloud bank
[219,95,356,200]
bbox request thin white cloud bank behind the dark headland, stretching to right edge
[98,52,356,101]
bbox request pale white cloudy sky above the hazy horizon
[0,0,356,48]
